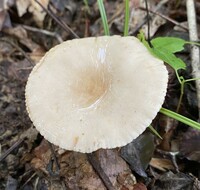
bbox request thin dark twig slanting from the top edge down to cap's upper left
[35,0,79,38]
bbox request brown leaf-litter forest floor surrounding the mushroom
[0,0,200,190]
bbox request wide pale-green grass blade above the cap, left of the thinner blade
[98,0,110,36]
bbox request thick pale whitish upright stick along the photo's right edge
[186,0,200,119]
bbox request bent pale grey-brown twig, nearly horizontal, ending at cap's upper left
[16,24,63,43]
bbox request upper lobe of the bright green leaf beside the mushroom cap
[151,37,187,53]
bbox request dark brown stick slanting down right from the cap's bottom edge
[87,153,115,190]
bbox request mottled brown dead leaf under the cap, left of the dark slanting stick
[59,151,106,190]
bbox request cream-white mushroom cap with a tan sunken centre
[26,36,168,152]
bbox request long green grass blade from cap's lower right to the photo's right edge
[160,108,200,130]
